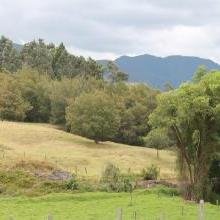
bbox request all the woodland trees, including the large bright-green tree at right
[0,37,220,200]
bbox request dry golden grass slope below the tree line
[0,121,176,178]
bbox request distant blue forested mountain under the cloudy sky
[98,54,220,88]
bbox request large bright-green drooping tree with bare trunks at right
[150,72,220,200]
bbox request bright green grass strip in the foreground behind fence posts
[0,190,220,220]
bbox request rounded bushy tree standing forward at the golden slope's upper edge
[66,91,119,143]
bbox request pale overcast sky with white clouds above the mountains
[0,0,220,63]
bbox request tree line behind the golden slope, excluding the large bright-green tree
[0,37,159,145]
